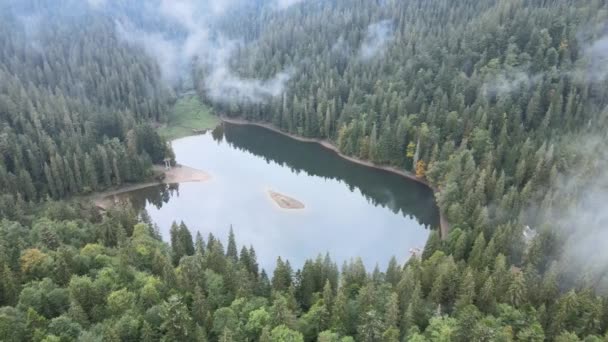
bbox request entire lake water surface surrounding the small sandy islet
[122,124,439,270]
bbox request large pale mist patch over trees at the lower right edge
[546,132,608,293]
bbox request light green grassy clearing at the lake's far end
[158,95,220,140]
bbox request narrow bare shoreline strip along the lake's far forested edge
[220,116,450,239]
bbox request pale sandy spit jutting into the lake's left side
[91,165,211,209]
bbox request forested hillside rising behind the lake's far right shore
[202,0,608,308]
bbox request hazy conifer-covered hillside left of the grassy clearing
[0,0,171,217]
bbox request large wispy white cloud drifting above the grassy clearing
[116,0,299,103]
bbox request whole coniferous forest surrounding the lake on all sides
[0,0,608,342]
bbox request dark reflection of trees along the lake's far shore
[216,124,439,227]
